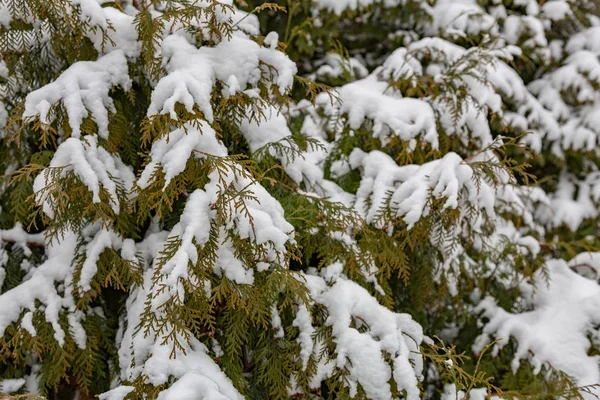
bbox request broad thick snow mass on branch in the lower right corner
[474,260,600,386]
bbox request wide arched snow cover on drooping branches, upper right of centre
[320,34,536,148]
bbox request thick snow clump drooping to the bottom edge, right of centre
[302,275,423,399]
